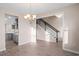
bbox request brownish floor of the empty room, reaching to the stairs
[0,40,77,56]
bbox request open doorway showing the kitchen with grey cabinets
[5,14,19,50]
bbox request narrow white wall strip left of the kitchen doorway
[0,11,6,51]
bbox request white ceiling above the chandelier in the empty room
[0,3,72,14]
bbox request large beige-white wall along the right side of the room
[63,4,79,54]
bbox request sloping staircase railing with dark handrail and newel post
[36,18,59,43]
